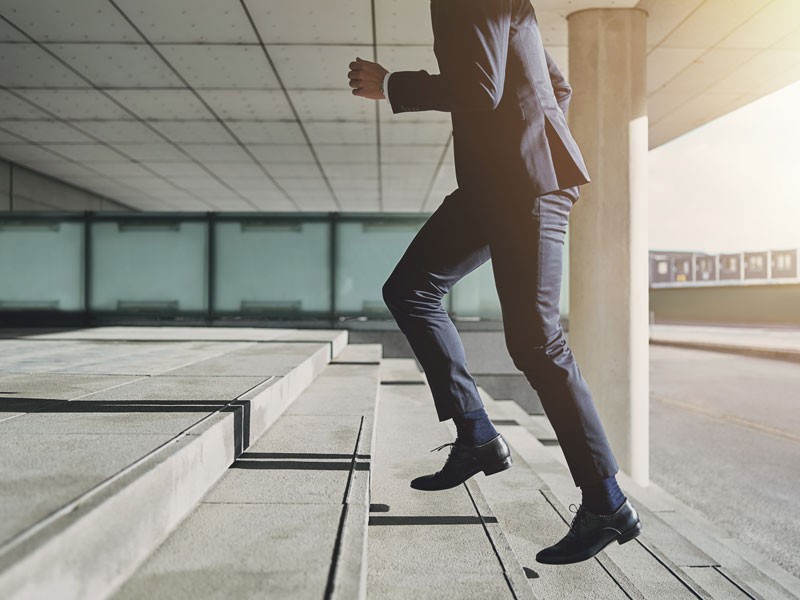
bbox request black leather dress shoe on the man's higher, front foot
[411,433,512,491]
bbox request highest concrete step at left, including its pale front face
[0,328,347,599]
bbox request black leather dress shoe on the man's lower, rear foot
[536,498,642,565]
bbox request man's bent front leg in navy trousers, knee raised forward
[383,189,489,421]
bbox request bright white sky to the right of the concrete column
[649,82,800,253]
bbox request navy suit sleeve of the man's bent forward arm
[389,0,511,113]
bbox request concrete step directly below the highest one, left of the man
[114,344,381,600]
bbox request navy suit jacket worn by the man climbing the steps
[389,0,589,202]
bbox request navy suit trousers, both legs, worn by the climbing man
[383,187,618,485]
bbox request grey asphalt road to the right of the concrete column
[650,346,800,577]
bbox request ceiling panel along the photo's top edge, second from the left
[112,0,255,44]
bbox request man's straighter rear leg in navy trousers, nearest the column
[482,188,618,486]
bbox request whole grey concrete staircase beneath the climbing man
[0,327,800,600]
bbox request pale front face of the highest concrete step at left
[0,336,334,600]
